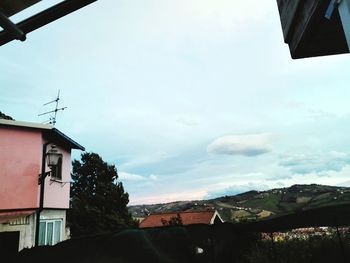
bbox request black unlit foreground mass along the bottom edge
[7,224,350,263]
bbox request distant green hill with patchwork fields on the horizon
[129,184,350,222]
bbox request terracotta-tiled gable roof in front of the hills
[140,210,222,228]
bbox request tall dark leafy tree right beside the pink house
[67,153,136,237]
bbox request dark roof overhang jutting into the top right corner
[277,0,349,59]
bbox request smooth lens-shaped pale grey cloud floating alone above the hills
[207,134,272,156]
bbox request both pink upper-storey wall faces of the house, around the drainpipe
[0,127,71,210]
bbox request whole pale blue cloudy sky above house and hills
[0,0,350,204]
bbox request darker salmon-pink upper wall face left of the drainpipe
[0,127,42,210]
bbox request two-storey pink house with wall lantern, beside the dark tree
[0,119,85,251]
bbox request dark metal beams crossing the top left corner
[0,0,97,46]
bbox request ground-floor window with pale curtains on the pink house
[39,220,62,246]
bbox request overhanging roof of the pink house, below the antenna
[0,119,85,151]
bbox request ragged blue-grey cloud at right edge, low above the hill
[279,151,350,176]
